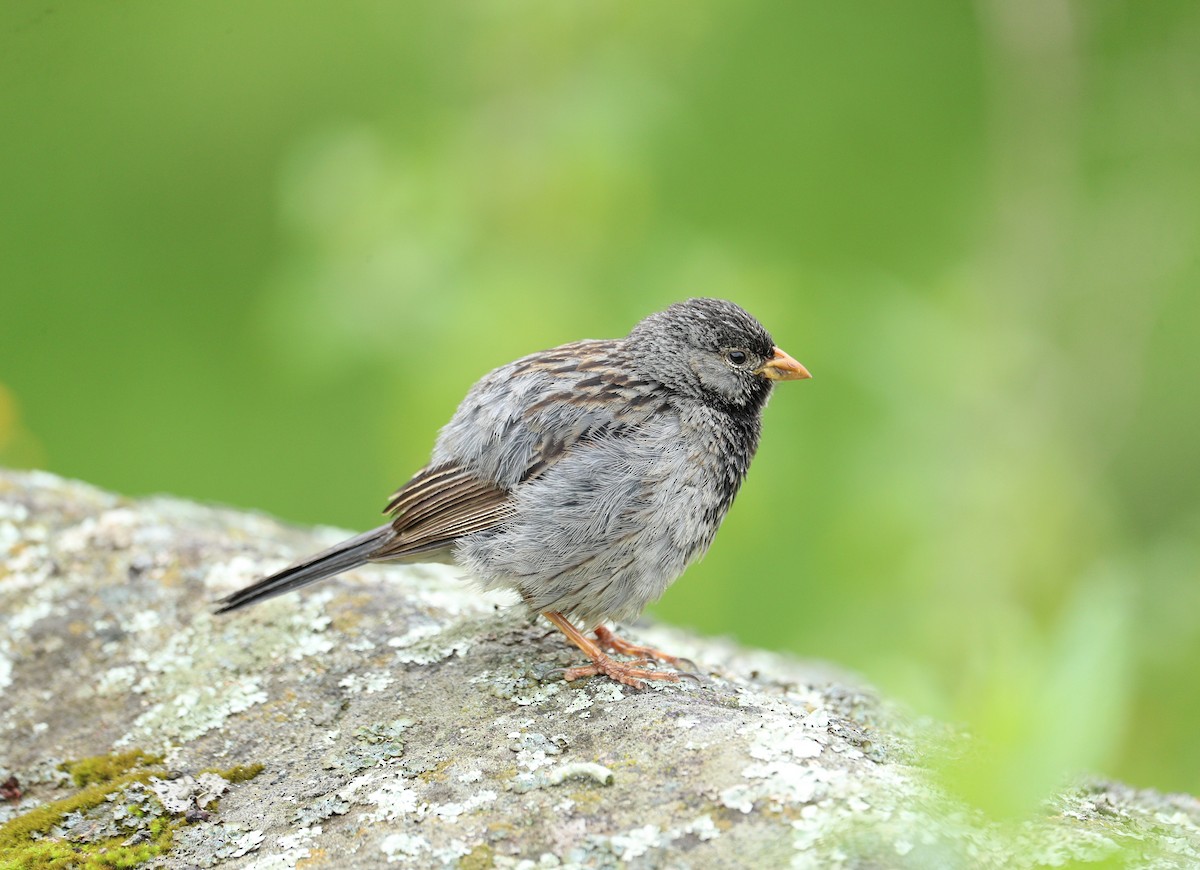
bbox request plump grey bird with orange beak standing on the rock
[216,298,811,689]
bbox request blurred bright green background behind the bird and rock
[0,0,1200,812]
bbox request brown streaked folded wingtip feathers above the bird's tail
[371,462,512,560]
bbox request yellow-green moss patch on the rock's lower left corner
[0,750,171,870]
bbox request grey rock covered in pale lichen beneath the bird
[0,472,1200,868]
